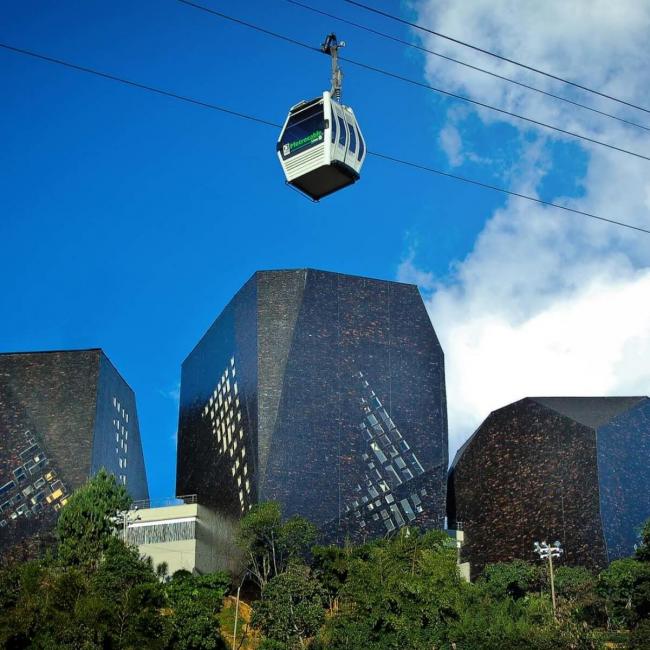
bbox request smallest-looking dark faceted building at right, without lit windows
[447,397,650,575]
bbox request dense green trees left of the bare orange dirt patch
[0,471,230,650]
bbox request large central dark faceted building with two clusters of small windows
[177,269,448,541]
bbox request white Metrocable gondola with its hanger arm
[277,34,366,201]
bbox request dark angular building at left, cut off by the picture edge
[0,349,148,558]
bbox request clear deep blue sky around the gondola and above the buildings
[0,0,644,497]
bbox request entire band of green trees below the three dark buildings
[0,472,650,650]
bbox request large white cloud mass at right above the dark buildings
[408,0,650,455]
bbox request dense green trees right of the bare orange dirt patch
[240,503,650,650]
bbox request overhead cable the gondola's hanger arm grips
[177,0,650,161]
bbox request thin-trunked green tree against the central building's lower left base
[238,501,317,589]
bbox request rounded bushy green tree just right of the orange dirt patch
[251,563,325,648]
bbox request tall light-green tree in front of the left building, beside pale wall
[56,469,131,565]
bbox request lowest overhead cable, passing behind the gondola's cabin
[0,42,650,235]
